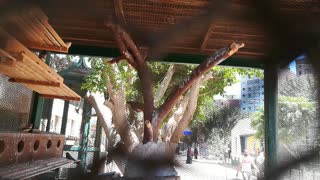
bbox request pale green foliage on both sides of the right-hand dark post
[251,96,316,144]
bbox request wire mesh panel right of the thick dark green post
[277,55,320,180]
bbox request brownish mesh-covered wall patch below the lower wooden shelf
[0,74,32,131]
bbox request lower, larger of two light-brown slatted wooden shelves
[0,26,80,101]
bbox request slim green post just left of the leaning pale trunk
[79,100,92,172]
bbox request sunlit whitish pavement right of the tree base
[175,156,255,180]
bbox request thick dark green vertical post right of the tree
[264,64,278,171]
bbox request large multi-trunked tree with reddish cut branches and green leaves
[83,22,248,172]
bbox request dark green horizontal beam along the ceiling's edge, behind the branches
[69,45,264,68]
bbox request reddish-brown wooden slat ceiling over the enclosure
[3,0,320,66]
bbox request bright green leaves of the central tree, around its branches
[82,58,262,132]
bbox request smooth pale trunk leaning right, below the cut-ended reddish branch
[170,79,202,143]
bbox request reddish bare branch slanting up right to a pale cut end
[153,43,244,134]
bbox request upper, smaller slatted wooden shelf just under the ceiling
[0,6,71,53]
